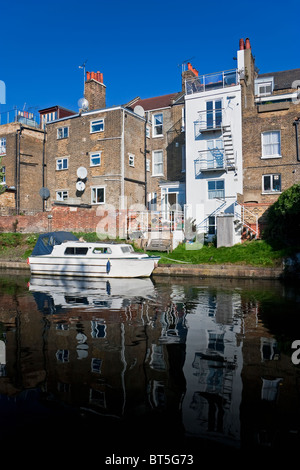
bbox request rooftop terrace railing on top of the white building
[185,69,239,95]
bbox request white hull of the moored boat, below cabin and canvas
[29,255,159,278]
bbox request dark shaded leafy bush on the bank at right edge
[263,183,300,246]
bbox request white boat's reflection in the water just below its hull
[29,275,155,313]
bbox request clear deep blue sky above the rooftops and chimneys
[0,0,300,116]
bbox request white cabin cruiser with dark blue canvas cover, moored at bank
[28,232,159,278]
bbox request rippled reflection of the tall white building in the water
[183,290,242,446]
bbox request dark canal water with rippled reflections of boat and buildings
[0,271,300,458]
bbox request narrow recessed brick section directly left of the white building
[128,91,185,213]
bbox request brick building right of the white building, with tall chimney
[238,40,300,234]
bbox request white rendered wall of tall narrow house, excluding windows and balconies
[185,85,242,231]
